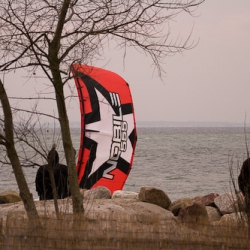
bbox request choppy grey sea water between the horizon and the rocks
[0,127,250,201]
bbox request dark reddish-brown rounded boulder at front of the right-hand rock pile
[178,203,209,227]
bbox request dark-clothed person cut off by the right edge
[238,158,250,198]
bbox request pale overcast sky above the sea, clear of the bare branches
[3,0,250,123]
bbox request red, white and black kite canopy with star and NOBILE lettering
[71,64,137,193]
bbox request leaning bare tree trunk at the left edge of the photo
[0,80,40,225]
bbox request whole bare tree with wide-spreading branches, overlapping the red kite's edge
[0,0,204,213]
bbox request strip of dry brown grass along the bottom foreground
[0,213,250,250]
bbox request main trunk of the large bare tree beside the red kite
[48,0,84,213]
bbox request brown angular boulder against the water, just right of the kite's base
[139,187,171,209]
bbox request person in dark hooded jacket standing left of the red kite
[35,147,70,200]
